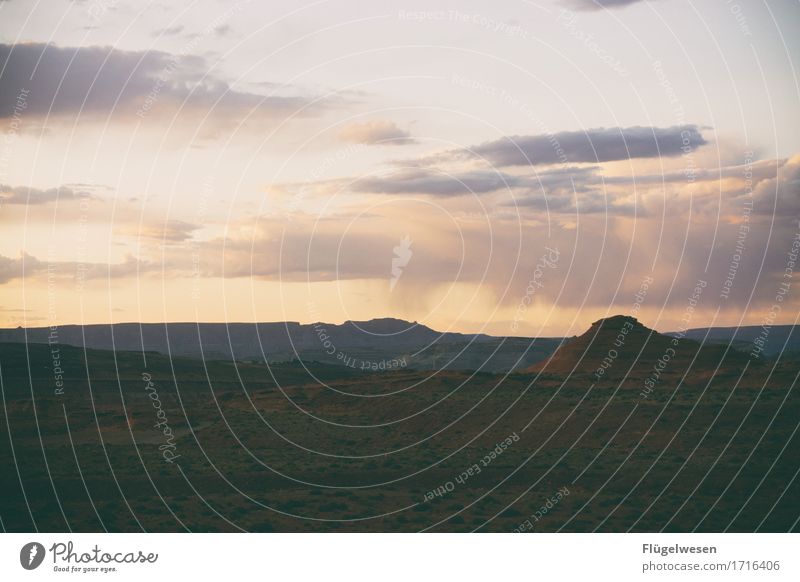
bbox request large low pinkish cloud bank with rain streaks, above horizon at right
[180,187,800,322]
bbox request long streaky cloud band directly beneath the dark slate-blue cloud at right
[271,147,788,229]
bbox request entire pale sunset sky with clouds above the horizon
[0,0,800,336]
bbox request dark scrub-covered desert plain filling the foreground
[0,320,800,532]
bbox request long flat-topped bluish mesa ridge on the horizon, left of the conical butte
[0,318,561,372]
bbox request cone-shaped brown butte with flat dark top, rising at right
[528,315,746,381]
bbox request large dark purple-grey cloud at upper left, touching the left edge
[0,43,328,121]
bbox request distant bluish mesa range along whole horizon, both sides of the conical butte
[0,315,800,372]
